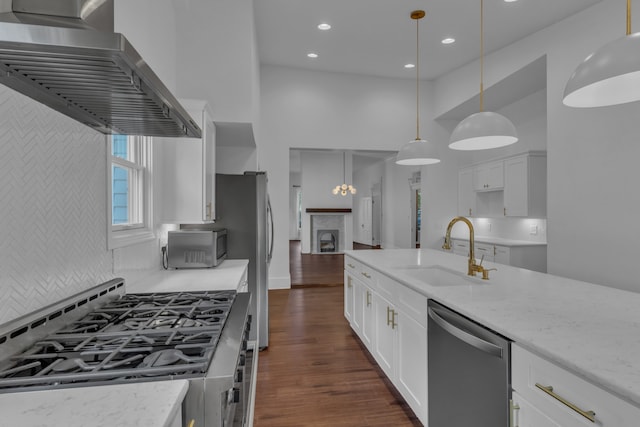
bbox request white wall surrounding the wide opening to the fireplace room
[258,65,450,287]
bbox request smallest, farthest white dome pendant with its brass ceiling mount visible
[396,10,440,166]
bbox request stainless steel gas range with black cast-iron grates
[0,279,253,427]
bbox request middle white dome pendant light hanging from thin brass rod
[449,0,518,150]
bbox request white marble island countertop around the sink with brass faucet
[345,249,640,406]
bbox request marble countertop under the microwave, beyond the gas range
[125,259,249,293]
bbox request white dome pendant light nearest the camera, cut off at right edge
[562,0,640,108]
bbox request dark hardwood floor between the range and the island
[254,242,421,427]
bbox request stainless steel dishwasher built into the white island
[428,300,511,427]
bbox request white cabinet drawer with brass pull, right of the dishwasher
[511,344,640,427]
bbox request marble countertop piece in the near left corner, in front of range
[0,380,189,427]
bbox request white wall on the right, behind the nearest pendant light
[435,0,640,292]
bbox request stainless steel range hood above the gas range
[0,0,201,138]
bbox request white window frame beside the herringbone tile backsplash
[106,135,155,249]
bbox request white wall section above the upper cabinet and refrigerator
[173,0,260,126]
